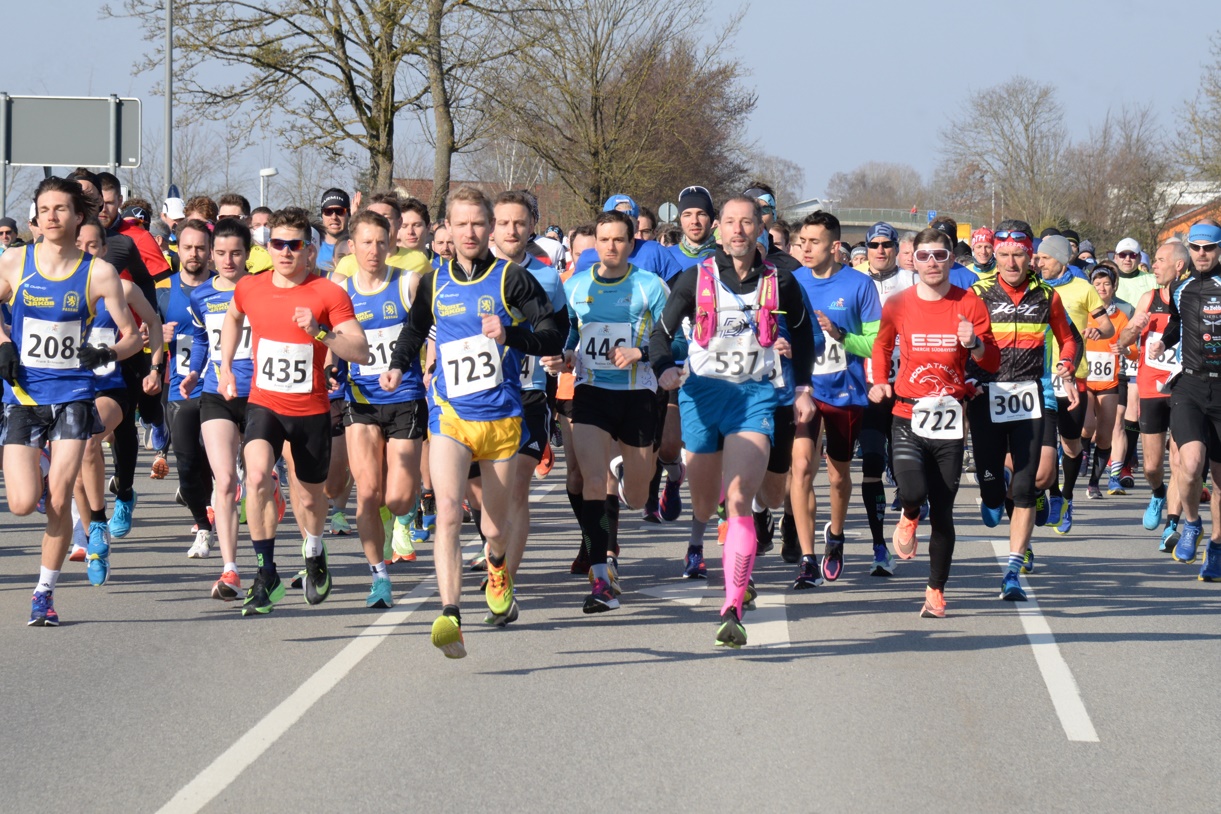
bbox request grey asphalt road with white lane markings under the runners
[0,456,1221,813]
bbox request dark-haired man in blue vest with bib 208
[0,176,143,626]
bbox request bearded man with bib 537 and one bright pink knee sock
[648,196,814,648]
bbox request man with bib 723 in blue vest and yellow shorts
[381,187,564,659]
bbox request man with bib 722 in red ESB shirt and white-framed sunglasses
[864,225,1000,619]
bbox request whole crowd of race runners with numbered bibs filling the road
[0,170,1221,658]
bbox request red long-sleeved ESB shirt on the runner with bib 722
[873,286,1000,419]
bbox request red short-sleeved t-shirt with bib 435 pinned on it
[233,272,357,415]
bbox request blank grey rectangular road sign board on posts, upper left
[0,96,140,168]
